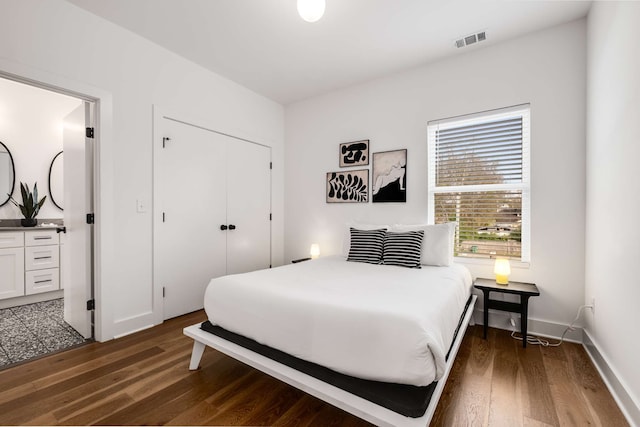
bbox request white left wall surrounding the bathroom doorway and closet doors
[0,0,284,339]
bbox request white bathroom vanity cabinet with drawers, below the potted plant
[0,229,60,299]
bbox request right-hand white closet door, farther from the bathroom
[227,138,271,274]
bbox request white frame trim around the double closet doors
[151,104,273,325]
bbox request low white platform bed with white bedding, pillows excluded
[184,256,476,426]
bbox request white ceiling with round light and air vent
[68,0,591,105]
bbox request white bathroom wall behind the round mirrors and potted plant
[0,78,80,219]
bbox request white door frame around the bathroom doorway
[0,58,115,341]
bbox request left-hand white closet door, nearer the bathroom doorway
[154,118,227,319]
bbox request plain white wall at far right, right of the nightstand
[585,2,640,425]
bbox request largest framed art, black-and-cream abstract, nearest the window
[371,149,407,203]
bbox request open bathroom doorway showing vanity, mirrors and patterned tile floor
[0,73,98,368]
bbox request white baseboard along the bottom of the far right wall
[582,330,640,426]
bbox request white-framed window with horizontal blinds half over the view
[427,104,530,262]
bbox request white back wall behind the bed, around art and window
[285,20,586,334]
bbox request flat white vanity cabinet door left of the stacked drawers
[0,232,24,299]
